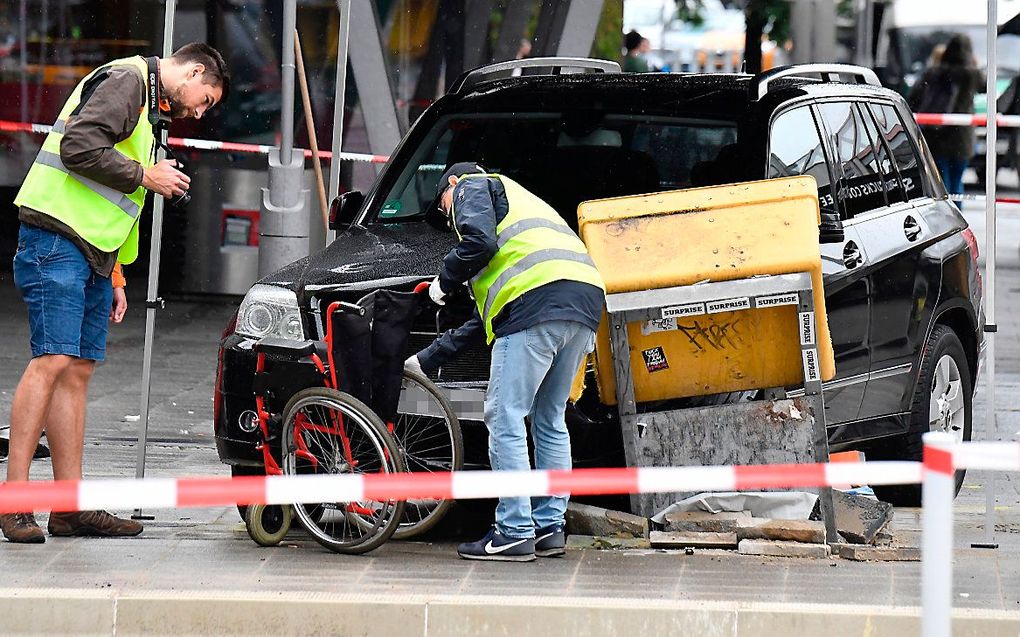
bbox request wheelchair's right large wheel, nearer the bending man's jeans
[391,371,464,539]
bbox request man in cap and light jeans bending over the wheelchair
[405,162,605,562]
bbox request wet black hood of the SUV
[259,222,457,300]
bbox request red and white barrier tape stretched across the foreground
[0,462,921,514]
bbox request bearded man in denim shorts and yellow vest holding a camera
[0,43,231,543]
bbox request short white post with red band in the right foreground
[921,432,956,637]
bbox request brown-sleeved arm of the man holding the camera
[60,67,145,193]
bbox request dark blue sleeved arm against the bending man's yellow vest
[440,178,497,294]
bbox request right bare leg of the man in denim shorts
[46,359,96,480]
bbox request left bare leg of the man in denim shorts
[7,354,73,482]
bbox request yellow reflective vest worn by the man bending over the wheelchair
[451,174,605,342]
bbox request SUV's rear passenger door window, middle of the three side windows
[818,102,886,219]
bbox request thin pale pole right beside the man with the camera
[132,0,177,518]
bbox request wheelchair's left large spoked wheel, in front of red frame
[283,387,404,553]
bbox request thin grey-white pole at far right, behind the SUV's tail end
[982,0,999,548]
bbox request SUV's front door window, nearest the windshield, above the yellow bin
[767,106,839,220]
